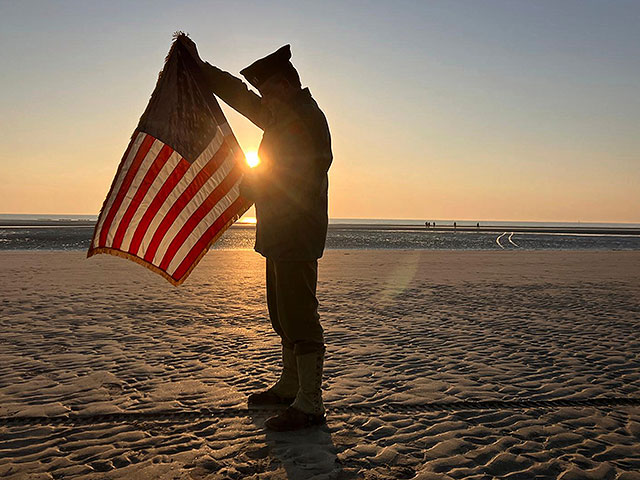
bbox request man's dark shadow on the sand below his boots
[251,411,342,480]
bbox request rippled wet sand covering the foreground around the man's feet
[0,250,640,480]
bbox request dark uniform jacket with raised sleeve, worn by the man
[205,64,333,261]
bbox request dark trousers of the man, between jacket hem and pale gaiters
[267,258,325,355]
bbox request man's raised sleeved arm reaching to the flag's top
[201,62,265,129]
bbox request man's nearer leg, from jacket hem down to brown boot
[266,261,325,430]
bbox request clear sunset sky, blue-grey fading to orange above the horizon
[0,0,640,222]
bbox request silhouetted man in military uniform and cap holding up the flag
[184,42,333,431]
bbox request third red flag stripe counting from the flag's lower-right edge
[144,142,230,263]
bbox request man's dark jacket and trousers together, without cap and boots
[205,65,333,351]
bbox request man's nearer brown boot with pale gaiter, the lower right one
[265,351,326,432]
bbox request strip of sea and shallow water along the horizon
[0,214,640,250]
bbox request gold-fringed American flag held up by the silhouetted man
[87,34,251,285]
